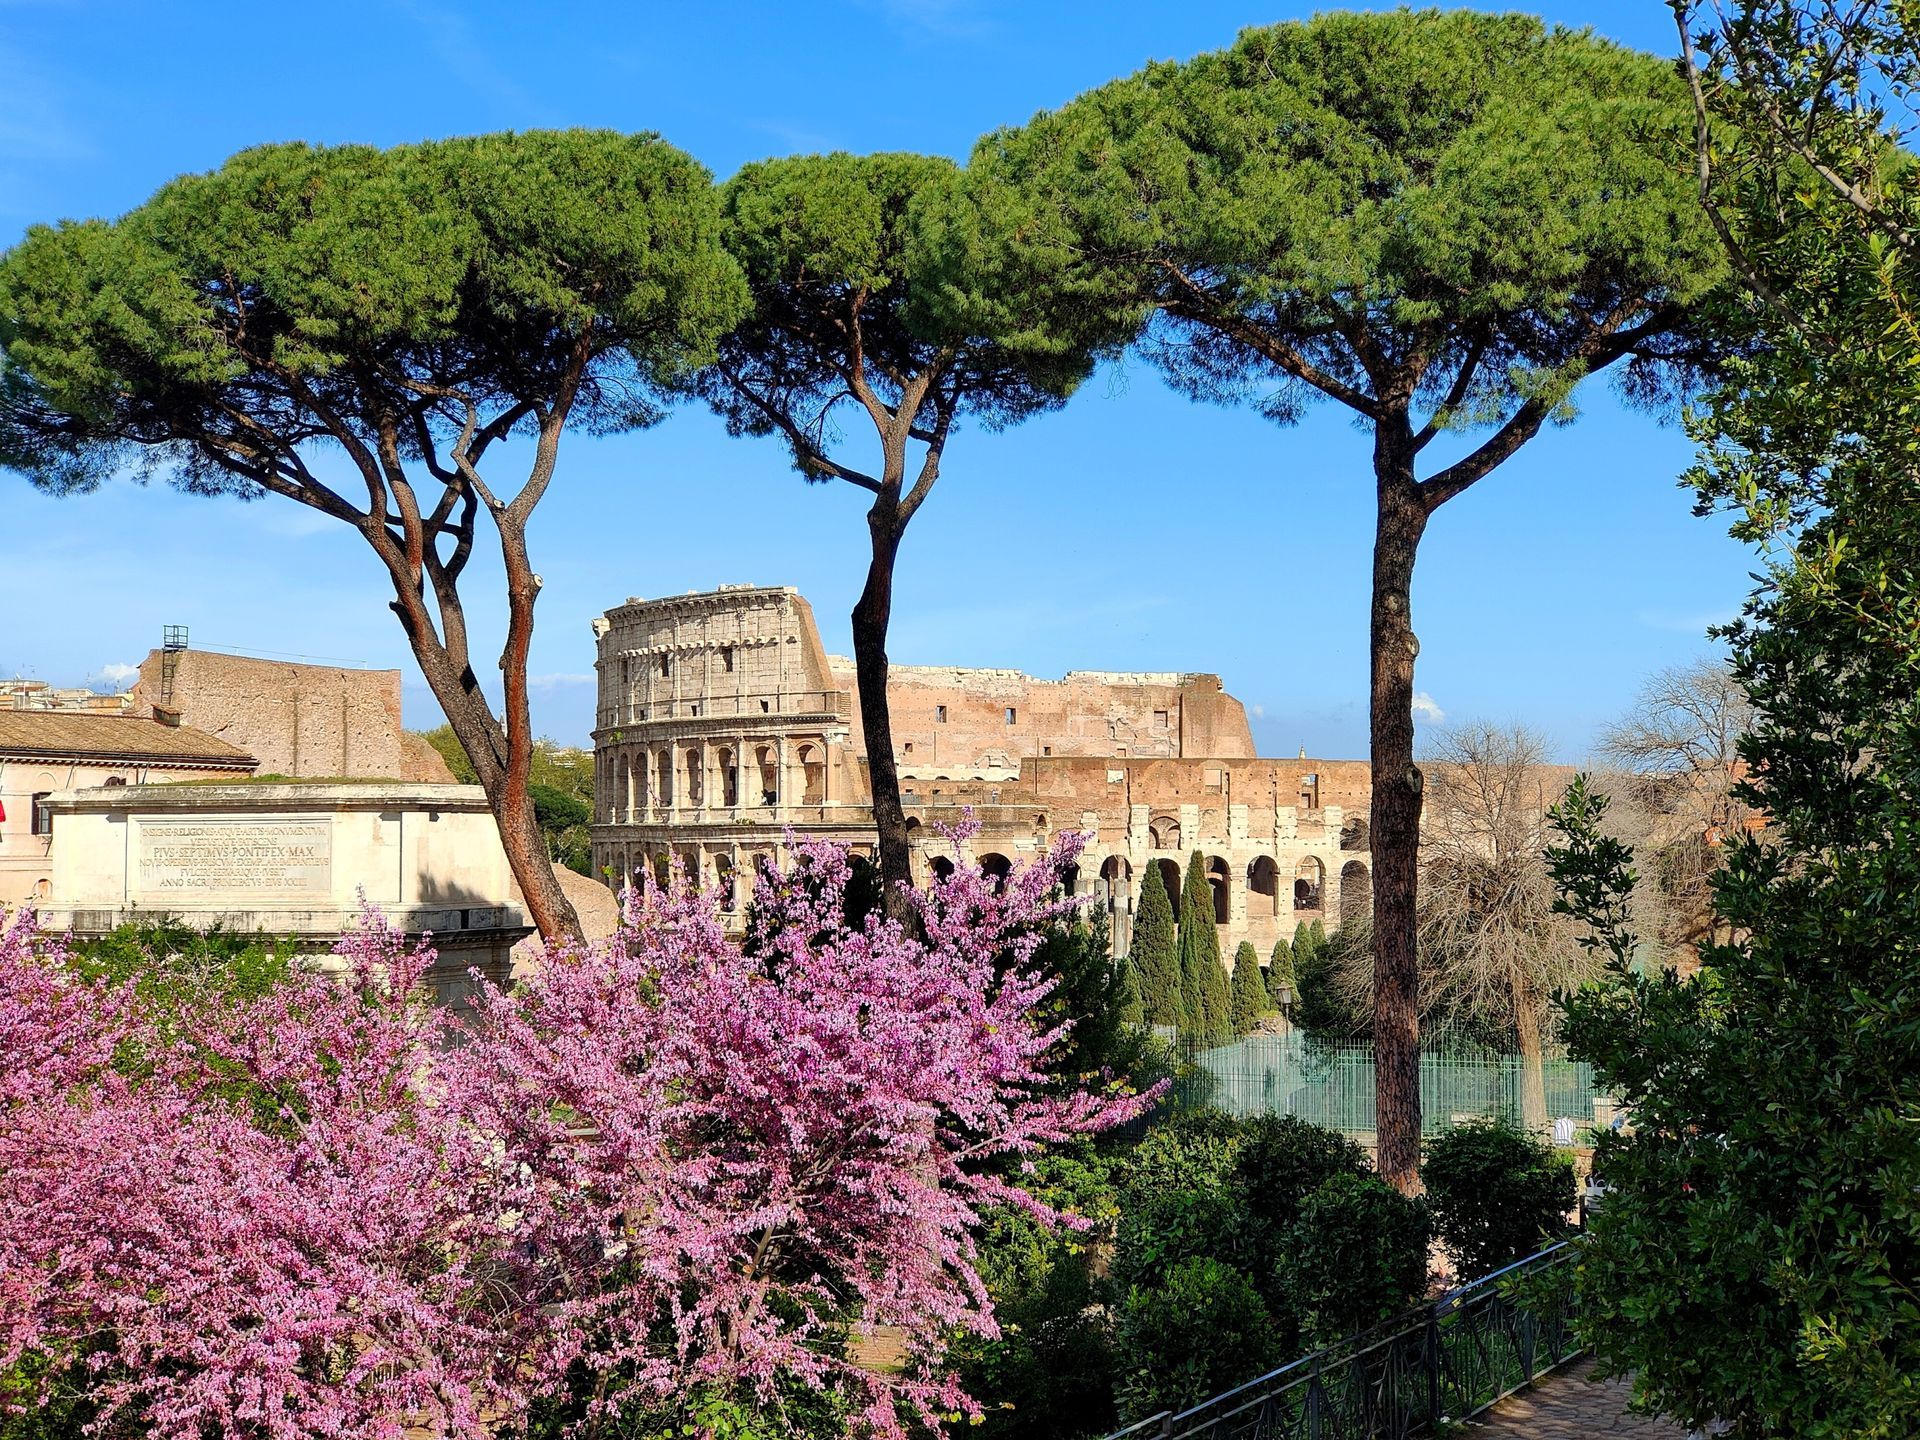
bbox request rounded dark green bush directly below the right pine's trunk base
[1275,1173,1432,1346]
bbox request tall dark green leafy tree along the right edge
[1528,0,1920,1440]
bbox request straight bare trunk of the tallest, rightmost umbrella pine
[1369,432,1427,1192]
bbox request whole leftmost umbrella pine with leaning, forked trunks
[0,131,747,939]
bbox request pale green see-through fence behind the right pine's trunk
[1173,1031,1613,1135]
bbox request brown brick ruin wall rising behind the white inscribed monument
[131,649,453,785]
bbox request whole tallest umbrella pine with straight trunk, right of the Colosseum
[973,10,1728,1187]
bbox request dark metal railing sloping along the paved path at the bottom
[1108,1240,1578,1440]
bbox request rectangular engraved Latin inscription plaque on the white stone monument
[131,816,332,900]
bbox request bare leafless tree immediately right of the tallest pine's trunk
[1334,724,1597,1129]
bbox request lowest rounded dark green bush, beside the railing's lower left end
[1119,1258,1284,1421]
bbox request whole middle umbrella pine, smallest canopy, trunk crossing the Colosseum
[705,154,1142,920]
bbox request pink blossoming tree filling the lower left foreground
[0,841,1144,1440]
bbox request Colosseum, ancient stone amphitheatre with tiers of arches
[593,586,1371,952]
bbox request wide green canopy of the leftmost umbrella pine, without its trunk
[0,131,745,503]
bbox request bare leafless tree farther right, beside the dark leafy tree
[1599,659,1753,962]
